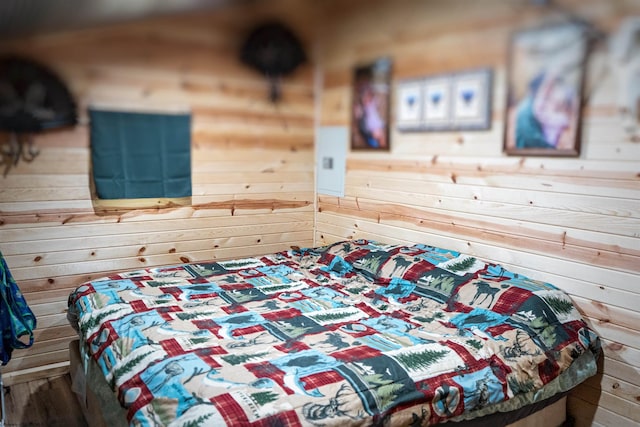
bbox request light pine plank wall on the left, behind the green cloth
[0,1,315,383]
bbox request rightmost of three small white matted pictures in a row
[451,69,491,130]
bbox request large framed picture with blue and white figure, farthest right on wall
[504,23,588,156]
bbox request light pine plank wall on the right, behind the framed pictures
[316,0,640,426]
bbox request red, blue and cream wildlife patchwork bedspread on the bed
[69,239,600,427]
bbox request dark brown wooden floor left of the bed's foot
[4,374,87,427]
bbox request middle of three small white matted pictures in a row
[422,75,451,130]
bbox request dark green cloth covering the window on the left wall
[89,109,191,199]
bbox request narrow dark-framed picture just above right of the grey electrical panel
[351,58,391,150]
